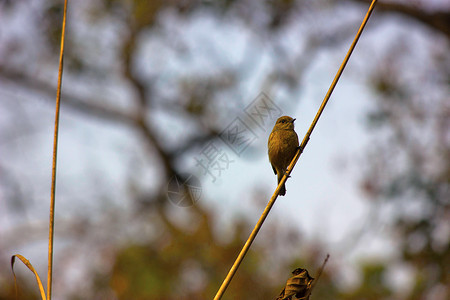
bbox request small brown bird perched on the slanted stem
[268,116,299,196]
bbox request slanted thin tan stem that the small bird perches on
[214,0,377,300]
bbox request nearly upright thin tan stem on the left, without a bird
[47,0,67,300]
